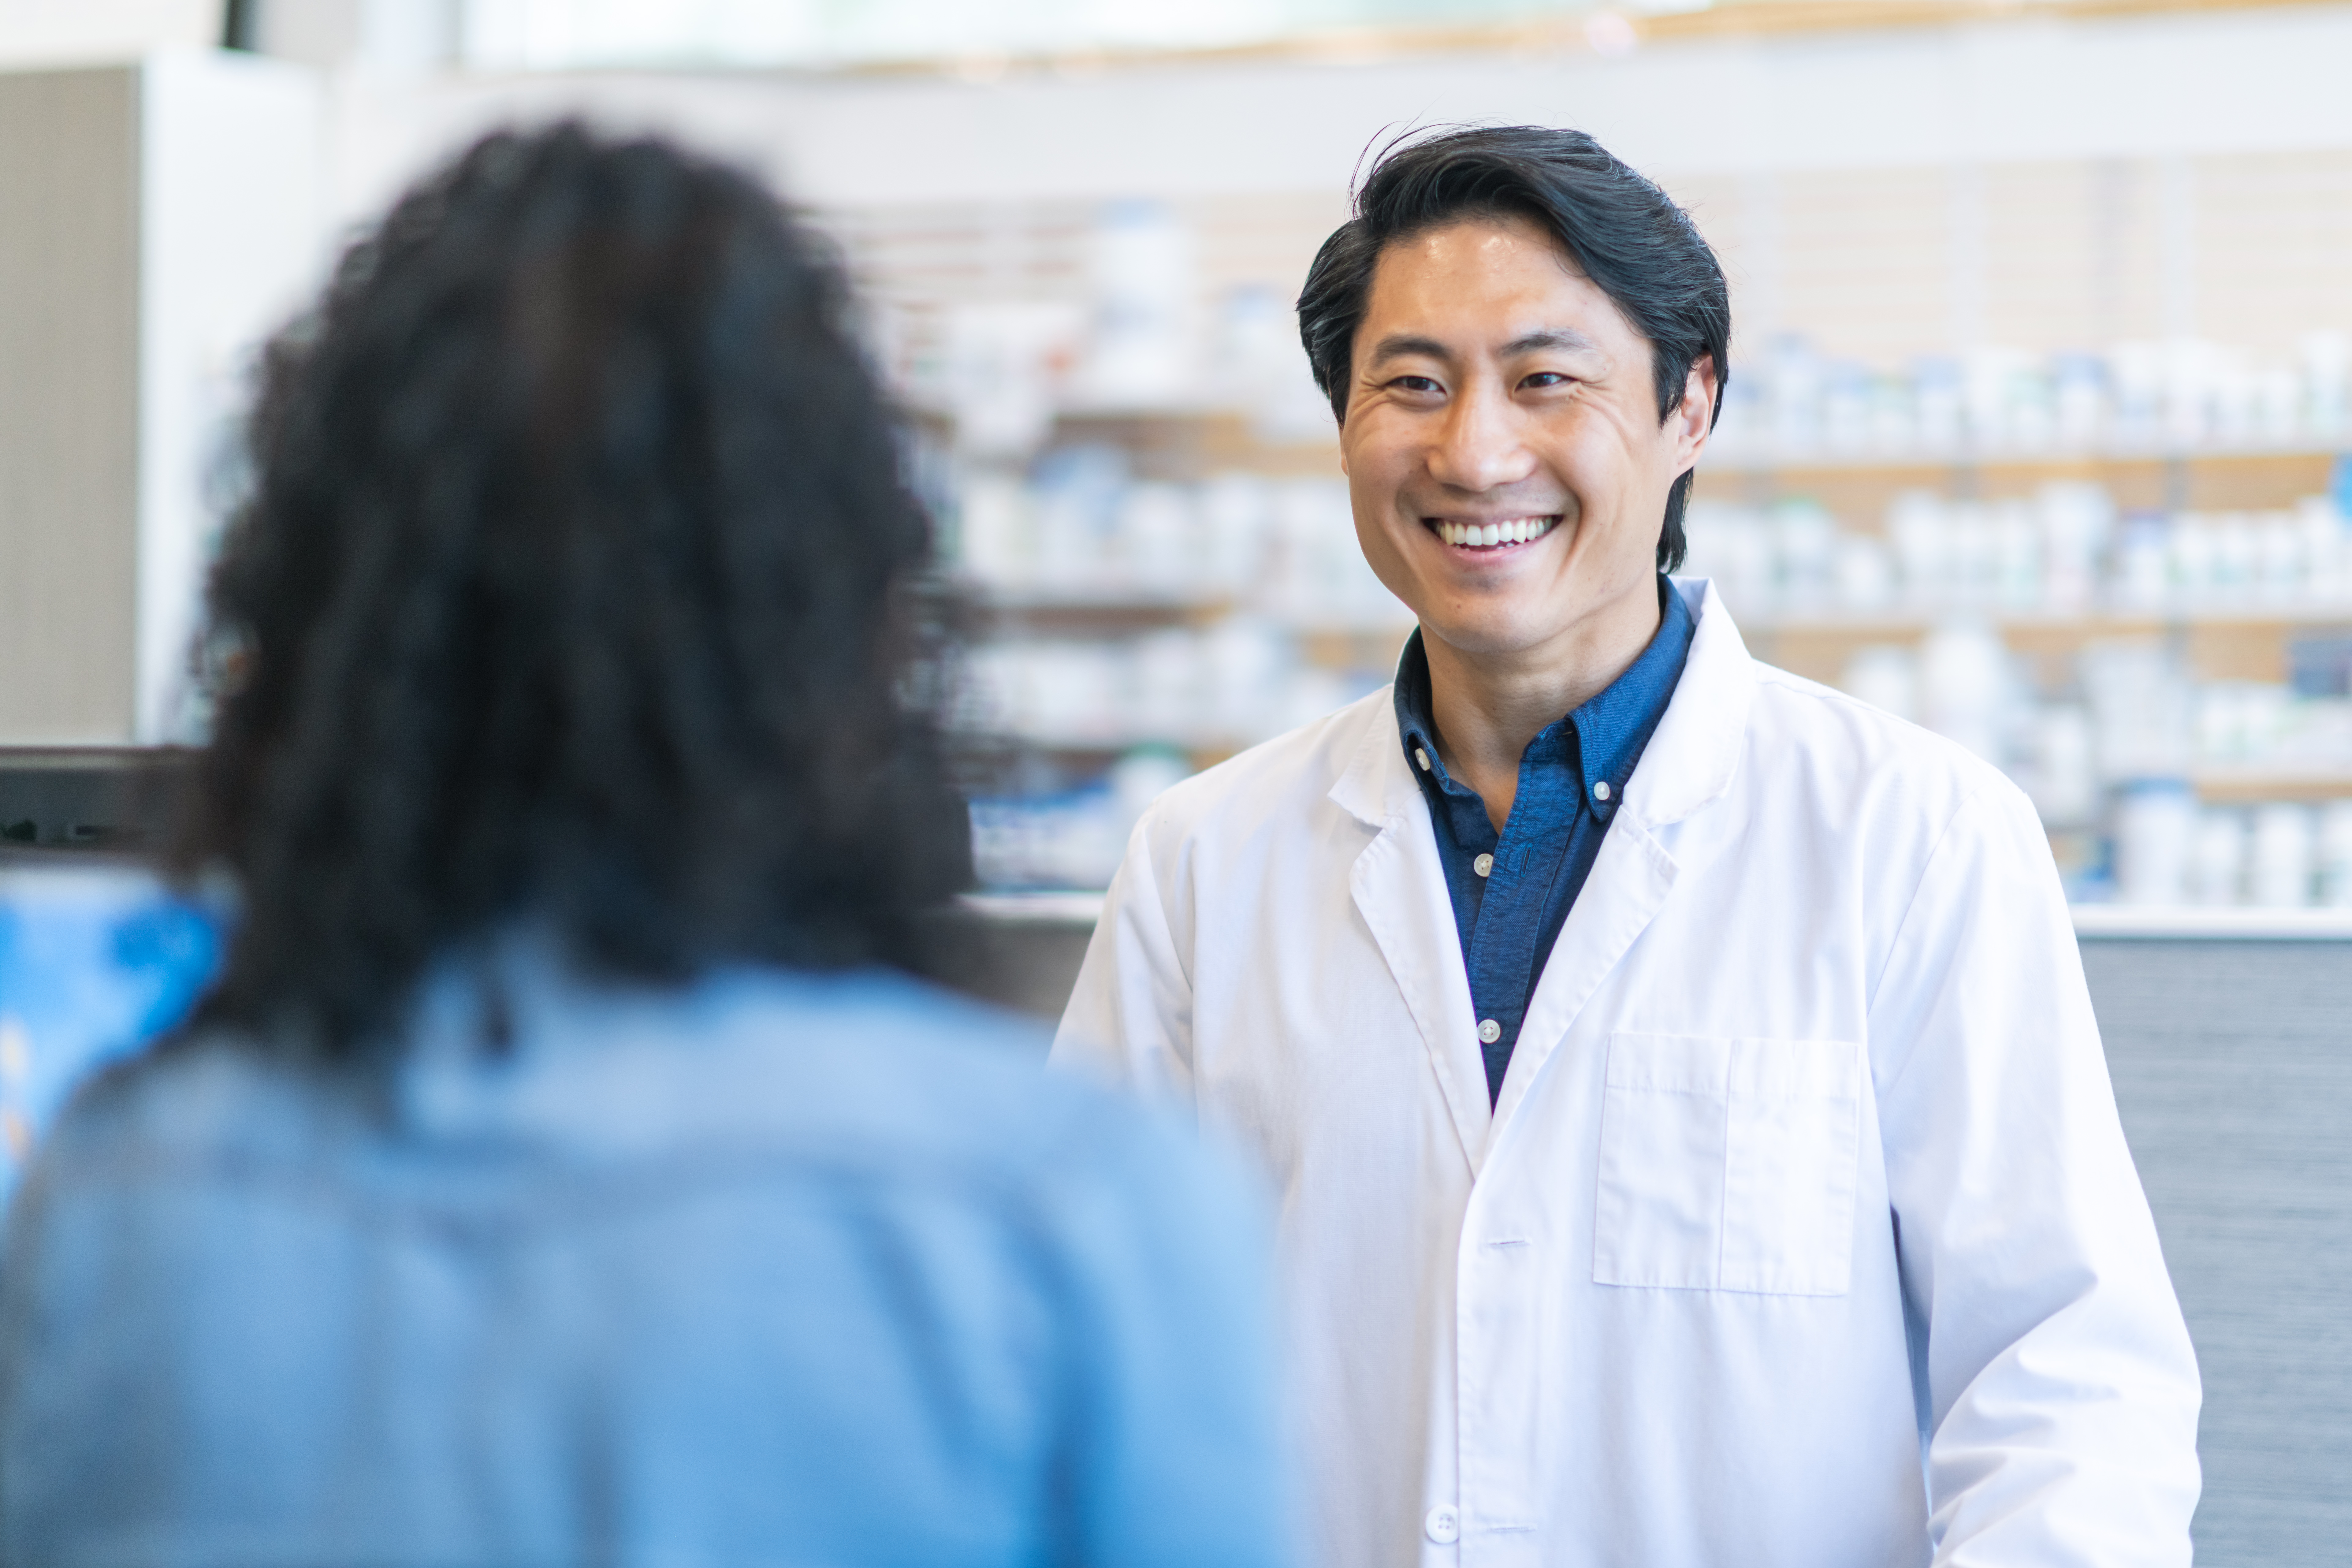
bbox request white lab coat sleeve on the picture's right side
[1870,780,2199,1568]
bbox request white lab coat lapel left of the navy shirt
[1331,710,1491,1173]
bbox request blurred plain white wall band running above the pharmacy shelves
[334,5,2352,212]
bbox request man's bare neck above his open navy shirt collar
[1421,578,1658,832]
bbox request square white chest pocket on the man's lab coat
[1592,1034,1863,1295]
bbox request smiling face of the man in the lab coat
[1341,219,1715,661]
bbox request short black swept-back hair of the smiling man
[1298,125,1731,571]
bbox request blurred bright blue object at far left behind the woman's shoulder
[0,867,221,1211]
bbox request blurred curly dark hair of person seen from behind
[172,125,971,1056]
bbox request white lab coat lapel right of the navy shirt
[1494,581,1755,1133]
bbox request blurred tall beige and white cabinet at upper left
[0,49,325,745]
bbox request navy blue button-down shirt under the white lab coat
[1397,576,1693,1103]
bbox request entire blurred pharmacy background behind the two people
[0,0,2352,1563]
